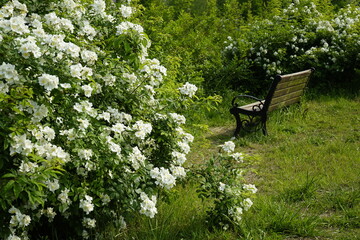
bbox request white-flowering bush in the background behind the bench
[224,0,360,91]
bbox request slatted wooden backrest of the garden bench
[264,68,314,111]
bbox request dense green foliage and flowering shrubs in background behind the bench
[140,0,360,95]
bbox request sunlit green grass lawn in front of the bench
[113,91,360,240]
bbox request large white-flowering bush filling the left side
[0,0,196,239]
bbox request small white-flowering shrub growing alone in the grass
[194,141,257,230]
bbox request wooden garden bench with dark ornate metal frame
[230,68,315,136]
